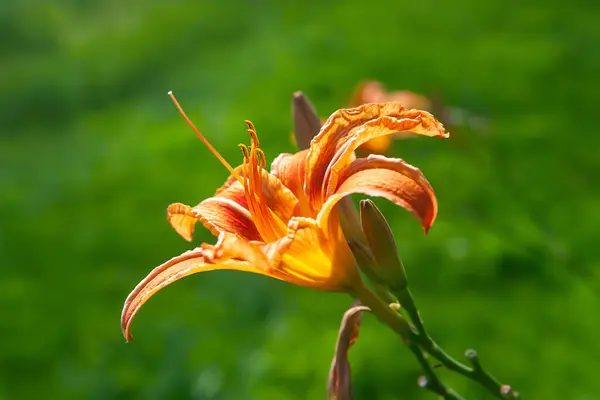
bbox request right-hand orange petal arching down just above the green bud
[317,155,438,233]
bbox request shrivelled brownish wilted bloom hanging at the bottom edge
[327,301,371,400]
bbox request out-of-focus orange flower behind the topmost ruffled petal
[350,81,432,154]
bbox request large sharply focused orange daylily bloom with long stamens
[121,98,448,340]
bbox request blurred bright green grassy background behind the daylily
[0,0,600,400]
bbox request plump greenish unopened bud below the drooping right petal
[360,200,408,291]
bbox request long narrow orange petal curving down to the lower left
[121,234,282,341]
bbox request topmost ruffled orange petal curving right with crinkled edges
[305,103,448,210]
